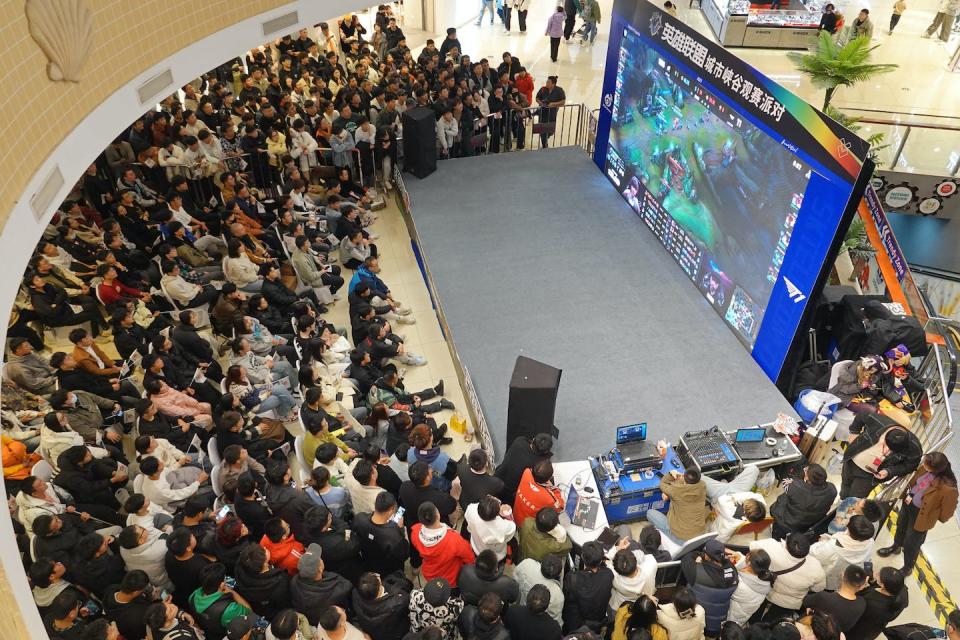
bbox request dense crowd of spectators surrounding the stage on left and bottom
[2,7,960,640]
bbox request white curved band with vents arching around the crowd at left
[0,0,376,638]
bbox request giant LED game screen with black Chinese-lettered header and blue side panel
[594,0,867,380]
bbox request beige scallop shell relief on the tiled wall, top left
[26,0,93,82]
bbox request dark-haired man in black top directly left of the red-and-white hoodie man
[350,491,410,576]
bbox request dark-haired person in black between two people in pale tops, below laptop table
[563,541,613,633]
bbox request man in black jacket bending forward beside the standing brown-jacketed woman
[840,413,923,499]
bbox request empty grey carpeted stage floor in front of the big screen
[406,148,793,460]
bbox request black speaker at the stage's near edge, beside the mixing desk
[507,356,563,443]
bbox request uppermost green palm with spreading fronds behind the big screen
[787,30,899,110]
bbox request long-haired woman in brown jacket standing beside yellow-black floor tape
[877,451,957,574]
